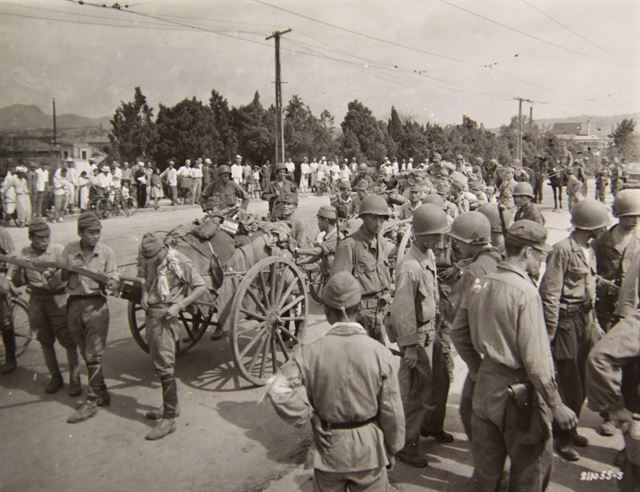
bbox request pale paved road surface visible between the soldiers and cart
[0,185,622,492]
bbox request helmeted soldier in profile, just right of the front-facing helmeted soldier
[389,204,449,467]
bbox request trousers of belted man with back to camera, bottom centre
[313,467,390,492]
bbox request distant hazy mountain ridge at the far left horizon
[0,104,109,131]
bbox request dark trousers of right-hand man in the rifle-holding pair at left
[67,295,109,400]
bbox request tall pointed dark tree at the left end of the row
[109,87,155,162]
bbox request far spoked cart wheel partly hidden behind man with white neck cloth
[128,301,215,356]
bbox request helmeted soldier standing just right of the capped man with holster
[540,199,609,461]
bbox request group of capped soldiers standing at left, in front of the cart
[0,212,208,440]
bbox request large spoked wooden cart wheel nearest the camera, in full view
[229,256,309,386]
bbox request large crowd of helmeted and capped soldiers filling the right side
[268,166,640,490]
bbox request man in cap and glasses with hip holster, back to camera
[451,220,577,490]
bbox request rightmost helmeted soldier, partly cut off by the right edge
[592,190,640,436]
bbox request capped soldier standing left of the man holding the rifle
[11,219,82,396]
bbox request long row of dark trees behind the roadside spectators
[109,87,634,168]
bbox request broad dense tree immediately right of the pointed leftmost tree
[154,97,222,168]
